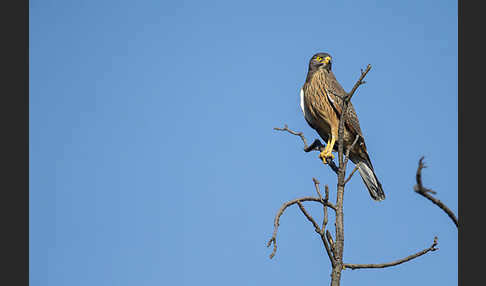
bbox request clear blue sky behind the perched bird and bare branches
[30,0,458,286]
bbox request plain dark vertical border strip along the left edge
[0,0,29,285]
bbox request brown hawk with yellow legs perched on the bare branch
[300,53,385,201]
